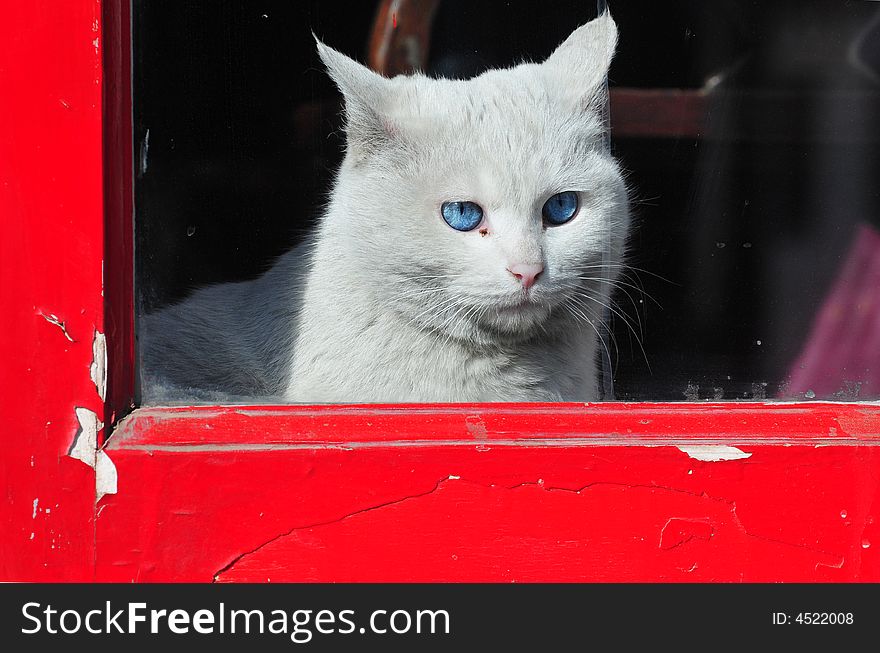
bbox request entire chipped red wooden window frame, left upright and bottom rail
[0,0,880,582]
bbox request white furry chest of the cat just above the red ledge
[287,306,593,402]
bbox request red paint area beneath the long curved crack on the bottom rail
[203,466,864,582]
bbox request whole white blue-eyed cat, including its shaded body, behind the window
[140,12,629,403]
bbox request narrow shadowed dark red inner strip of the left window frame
[103,0,135,424]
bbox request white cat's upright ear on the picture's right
[541,10,617,110]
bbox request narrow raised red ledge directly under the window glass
[114,402,880,448]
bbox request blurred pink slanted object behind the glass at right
[785,225,880,400]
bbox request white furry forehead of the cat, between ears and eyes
[407,78,607,209]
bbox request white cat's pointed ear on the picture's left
[312,34,395,157]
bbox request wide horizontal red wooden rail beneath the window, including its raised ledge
[97,404,880,582]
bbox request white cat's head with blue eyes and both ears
[318,13,629,338]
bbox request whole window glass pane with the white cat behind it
[134,0,880,403]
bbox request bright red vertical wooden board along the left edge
[0,0,104,581]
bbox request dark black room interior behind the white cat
[133,0,880,400]
